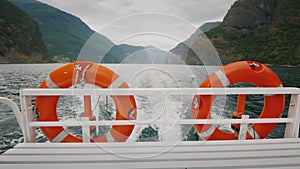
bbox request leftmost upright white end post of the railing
[20,93,36,143]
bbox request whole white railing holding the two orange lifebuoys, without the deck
[0,88,300,142]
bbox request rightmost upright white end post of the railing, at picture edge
[284,94,300,138]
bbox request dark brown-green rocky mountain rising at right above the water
[200,0,300,65]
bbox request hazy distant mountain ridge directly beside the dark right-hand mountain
[169,22,220,64]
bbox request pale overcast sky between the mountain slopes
[40,0,235,50]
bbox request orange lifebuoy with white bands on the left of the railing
[35,62,136,142]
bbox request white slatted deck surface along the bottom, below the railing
[0,138,300,169]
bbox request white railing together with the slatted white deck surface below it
[0,88,300,169]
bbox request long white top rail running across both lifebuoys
[21,87,300,96]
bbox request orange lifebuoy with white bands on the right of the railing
[191,61,285,140]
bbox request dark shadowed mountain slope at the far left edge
[0,0,50,63]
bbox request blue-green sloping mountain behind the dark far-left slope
[9,0,128,63]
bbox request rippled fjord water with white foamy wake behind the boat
[0,64,300,153]
